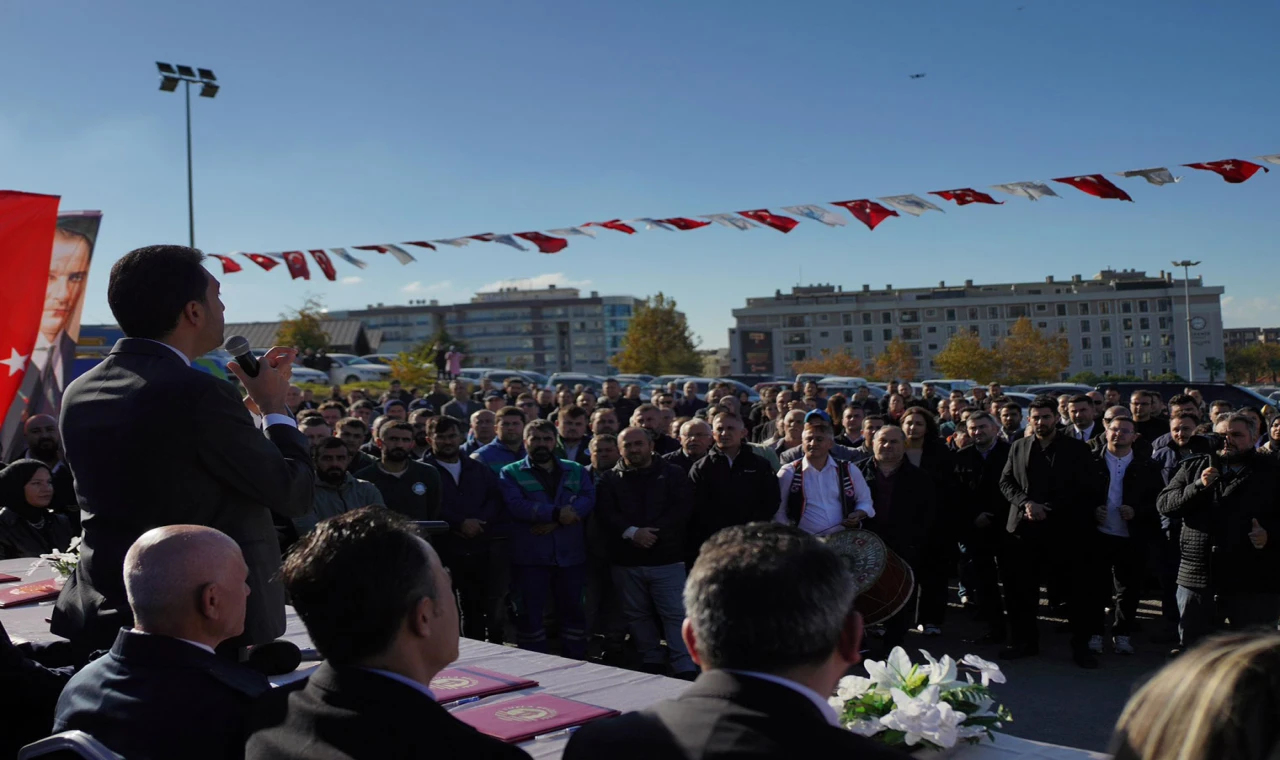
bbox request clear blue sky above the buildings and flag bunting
[0,0,1280,348]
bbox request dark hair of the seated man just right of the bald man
[282,507,437,665]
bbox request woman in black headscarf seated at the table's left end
[0,459,73,559]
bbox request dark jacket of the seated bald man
[54,631,271,760]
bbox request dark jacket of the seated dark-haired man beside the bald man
[246,663,529,760]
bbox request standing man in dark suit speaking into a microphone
[51,246,314,651]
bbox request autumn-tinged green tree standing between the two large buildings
[612,292,703,375]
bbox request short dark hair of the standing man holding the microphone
[106,246,209,340]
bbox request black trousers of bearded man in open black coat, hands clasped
[1000,531,1097,650]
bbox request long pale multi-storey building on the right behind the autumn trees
[730,270,1222,380]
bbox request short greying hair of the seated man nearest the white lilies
[685,522,854,673]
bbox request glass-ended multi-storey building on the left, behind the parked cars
[329,285,644,374]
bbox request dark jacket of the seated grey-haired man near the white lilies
[564,670,908,760]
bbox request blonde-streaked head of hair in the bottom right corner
[1111,631,1280,760]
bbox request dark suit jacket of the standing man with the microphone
[50,338,315,650]
